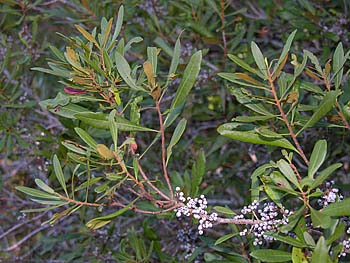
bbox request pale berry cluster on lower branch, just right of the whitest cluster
[234,200,292,246]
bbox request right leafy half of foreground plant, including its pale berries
[217,31,350,263]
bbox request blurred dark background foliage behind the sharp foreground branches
[0,0,350,262]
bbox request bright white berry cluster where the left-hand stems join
[174,187,218,235]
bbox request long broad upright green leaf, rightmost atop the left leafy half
[167,51,202,126]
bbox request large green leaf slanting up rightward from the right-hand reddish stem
[298,90,341,133]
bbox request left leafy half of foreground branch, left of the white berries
[17,3,211,237]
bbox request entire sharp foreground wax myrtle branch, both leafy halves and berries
[11,7,349,262]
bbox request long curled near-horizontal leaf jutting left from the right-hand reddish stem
[217,123,298,152]
